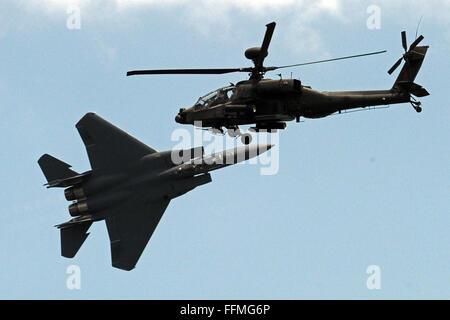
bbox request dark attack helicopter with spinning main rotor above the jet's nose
[127,22,429,144]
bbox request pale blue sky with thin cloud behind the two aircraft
[0,0,450,299]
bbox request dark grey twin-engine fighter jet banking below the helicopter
[38,113,273,271]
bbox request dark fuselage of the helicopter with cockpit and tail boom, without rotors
[175,79,410,130]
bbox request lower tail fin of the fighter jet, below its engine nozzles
[60,220,93,258]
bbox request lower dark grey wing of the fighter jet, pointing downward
[106,199,170,271]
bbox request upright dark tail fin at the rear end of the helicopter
[393,46,429,97]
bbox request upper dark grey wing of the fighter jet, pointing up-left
[76,113,156,169]
